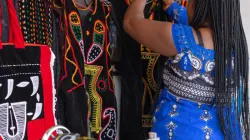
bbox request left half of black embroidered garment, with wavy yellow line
[54,0,88,136]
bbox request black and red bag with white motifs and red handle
[0,0,57,140]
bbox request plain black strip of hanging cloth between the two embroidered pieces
[111,0,143,140]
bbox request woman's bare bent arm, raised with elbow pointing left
[123,0,177,57]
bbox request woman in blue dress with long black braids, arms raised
[124,0,249,140]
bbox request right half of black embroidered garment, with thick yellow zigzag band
[79,0,117,140]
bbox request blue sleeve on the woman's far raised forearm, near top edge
[166,2,188,25]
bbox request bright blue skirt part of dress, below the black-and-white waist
[152,89,224,140]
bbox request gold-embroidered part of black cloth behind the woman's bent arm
[126,0,164,137]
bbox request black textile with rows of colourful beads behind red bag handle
[17,0,53,47]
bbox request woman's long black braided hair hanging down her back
[191,0,250,140]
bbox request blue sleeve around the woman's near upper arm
[172,24,194,54]
